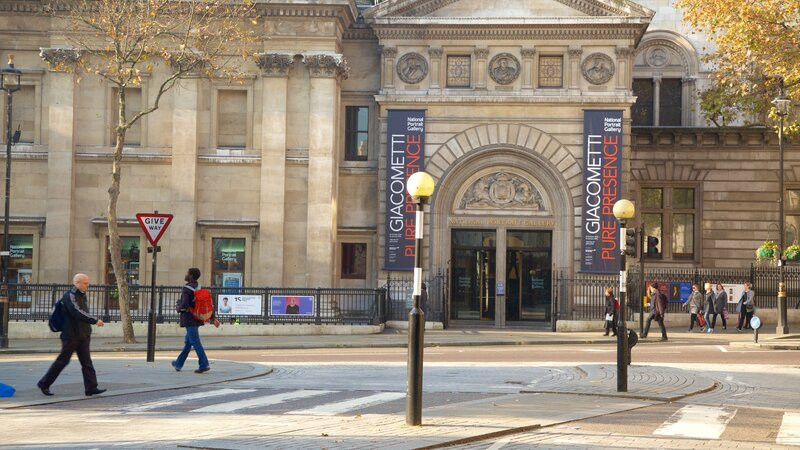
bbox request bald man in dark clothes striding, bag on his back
[36,273,106,396]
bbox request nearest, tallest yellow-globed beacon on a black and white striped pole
[406,172,435,426]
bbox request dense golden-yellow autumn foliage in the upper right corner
[676,0,800,131]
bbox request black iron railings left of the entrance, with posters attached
[9,284,386,325]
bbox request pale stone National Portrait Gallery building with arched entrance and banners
[0,0,800,321]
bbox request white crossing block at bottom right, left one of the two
[653,405,736,439]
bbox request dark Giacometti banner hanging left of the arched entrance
[383,110,425,270]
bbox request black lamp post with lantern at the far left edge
[0,55,22,348]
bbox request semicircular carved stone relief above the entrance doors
[459,172,544,211]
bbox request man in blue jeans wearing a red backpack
[172,267,219,373]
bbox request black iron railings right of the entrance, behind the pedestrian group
[553,265,800,320]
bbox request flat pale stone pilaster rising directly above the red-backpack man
[168,78,199,285]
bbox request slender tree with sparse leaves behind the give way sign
[43,0,257,343]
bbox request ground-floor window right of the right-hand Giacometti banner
[641,187,697,260]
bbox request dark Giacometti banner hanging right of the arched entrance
[581,110,622,273]
